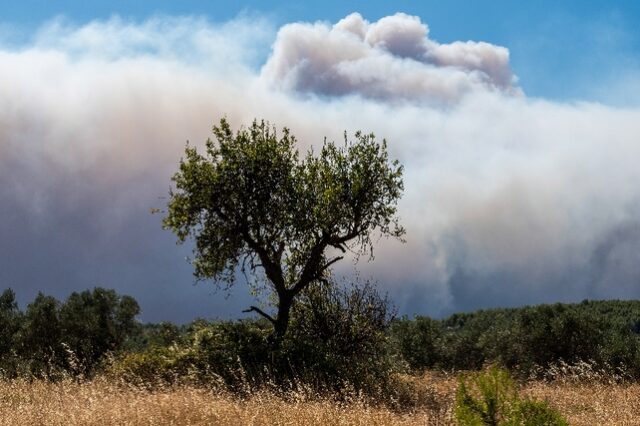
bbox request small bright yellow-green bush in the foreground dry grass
[455,367,568,426]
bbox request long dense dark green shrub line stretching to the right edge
[390,301,640,378]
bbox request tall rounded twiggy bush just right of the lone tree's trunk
[283,283,393,392]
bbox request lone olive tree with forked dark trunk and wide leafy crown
[163,119,404,341]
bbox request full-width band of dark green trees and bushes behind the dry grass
[5,283,640,388]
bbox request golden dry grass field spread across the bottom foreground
[0,374,640,426]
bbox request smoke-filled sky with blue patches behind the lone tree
[0,0,640,322]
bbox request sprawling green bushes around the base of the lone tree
[111,284,400,402]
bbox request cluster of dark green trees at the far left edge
[0,288,140,379]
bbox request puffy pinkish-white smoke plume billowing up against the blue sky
[263,13,519,105]
